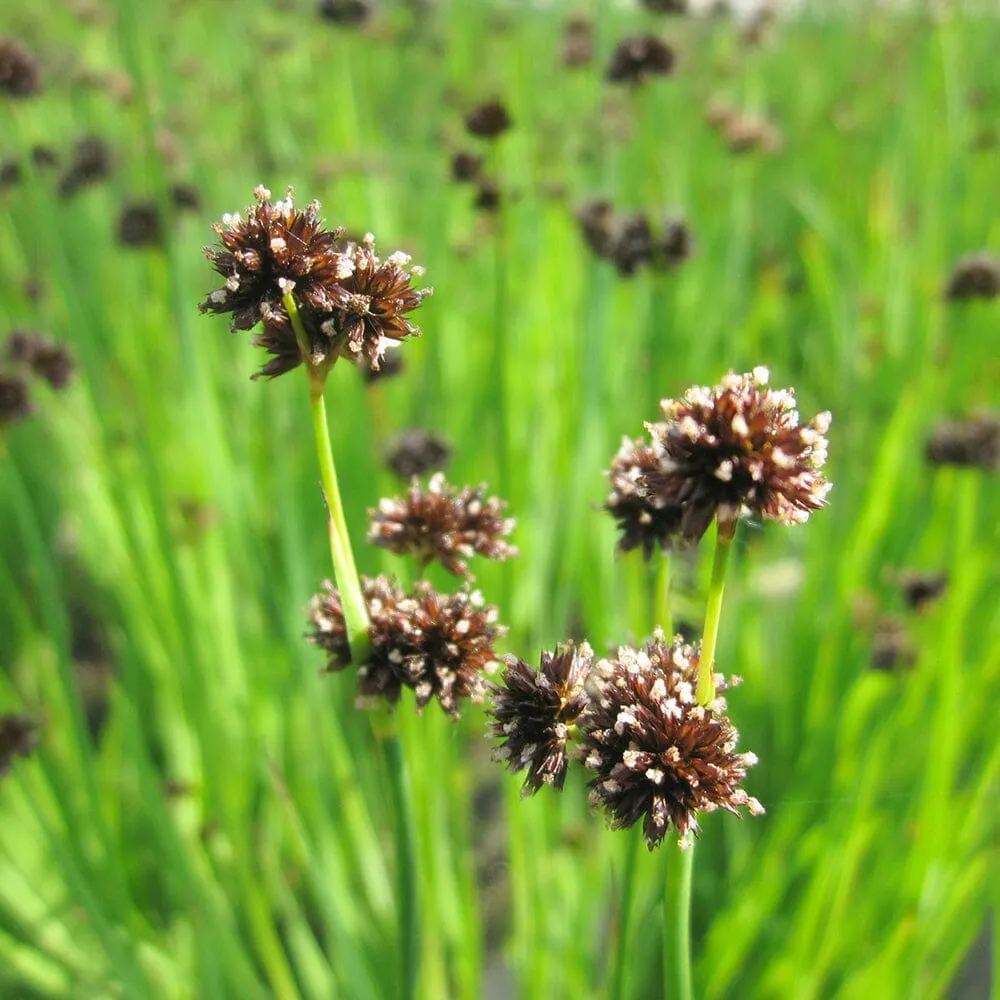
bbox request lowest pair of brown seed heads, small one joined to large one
[488,631,763,850]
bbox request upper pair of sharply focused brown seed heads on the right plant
[605,368,830,558]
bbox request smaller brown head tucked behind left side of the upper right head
[604,438,683,559]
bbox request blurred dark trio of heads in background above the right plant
[576,199,693,277]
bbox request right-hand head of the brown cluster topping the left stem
[320,233,433,370]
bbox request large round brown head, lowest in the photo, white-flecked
[579,632,764,850]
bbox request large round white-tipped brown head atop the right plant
[640,368,830,541]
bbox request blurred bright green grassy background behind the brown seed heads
[0,0,1000,1000]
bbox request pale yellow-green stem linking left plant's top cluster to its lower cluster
[282,292,369,664]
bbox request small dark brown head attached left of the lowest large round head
[487,642,594,795]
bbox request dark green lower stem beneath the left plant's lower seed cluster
[383,735,420,1000]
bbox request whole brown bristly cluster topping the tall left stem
[200,187,432,378]
